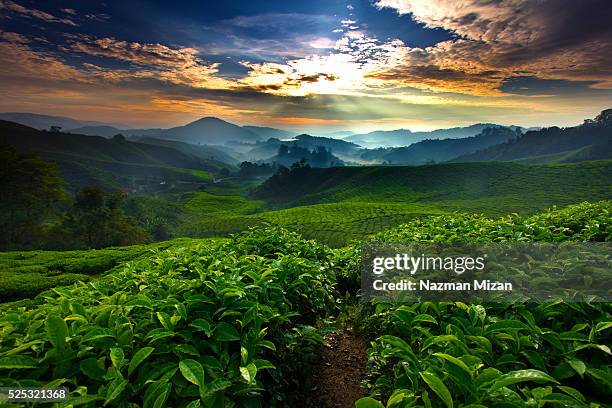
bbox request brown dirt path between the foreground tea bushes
[303,330,367,408]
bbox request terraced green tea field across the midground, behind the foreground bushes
[178,161,612,247]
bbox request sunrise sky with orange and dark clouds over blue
[0,0,612,133]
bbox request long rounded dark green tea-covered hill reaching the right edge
[253,161,612,214]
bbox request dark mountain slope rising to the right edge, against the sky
[453,109,612,163]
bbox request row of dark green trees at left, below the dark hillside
[0,146,151,250]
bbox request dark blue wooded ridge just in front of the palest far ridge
[361,127,521,165]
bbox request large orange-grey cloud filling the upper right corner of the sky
[376,0,612,94]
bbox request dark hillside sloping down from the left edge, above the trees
[0,121,233,189]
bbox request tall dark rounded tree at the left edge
[0,146,66,249]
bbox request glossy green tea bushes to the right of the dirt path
[354,201,612,407]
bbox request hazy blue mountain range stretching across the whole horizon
[1,109,612,171]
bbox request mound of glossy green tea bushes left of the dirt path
[0,229,335,407]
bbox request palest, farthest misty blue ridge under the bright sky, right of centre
[344,123,517,148]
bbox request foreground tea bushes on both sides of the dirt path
[0,201,612,408]
